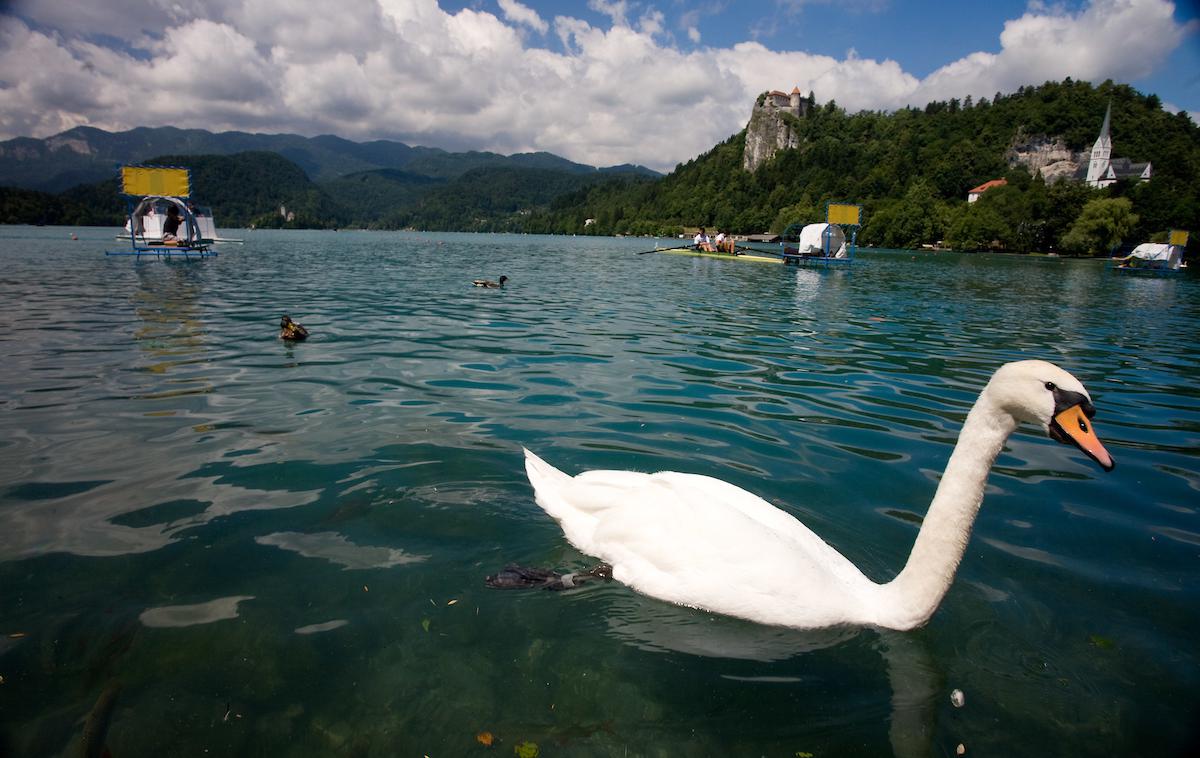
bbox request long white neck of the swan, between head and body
[877,391,1016,628]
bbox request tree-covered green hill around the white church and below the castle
[528,79,1200,252]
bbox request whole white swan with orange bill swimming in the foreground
[524,361,1114,630]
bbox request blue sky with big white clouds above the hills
[0,0,1200,172]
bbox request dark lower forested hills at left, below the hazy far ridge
[0,151,650,231]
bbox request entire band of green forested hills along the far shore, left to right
[0,79,1200,254]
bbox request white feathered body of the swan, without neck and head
[526,451,877,627]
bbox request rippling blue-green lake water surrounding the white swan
[0,227,1200,758]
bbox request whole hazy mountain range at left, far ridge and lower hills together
[0,127,660,230]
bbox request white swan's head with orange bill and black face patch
[986,361,1115,471]
